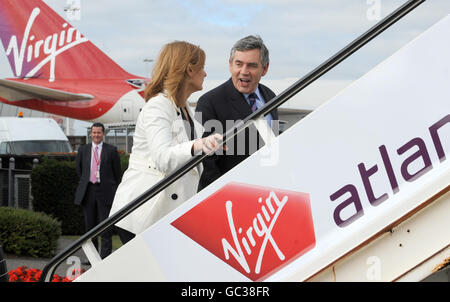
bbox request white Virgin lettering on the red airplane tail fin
[6,8,88,82]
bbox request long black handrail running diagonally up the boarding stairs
[40,0,425,282]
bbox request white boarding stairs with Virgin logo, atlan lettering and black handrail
[41,1,450,282]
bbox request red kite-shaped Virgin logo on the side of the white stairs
[172,183,316,281]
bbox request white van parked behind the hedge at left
[0,117,73,155]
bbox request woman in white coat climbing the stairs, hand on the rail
[110,41,222,243]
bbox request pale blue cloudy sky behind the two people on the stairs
[0,0,450,133]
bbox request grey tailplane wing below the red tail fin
[0,79,94,102]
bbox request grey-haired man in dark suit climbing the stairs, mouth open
[196,36,278,191]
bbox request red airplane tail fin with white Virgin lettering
[0,0,133,81]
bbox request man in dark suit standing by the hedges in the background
[75,123,122,259]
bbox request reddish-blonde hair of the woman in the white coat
[145,41,206,106]
